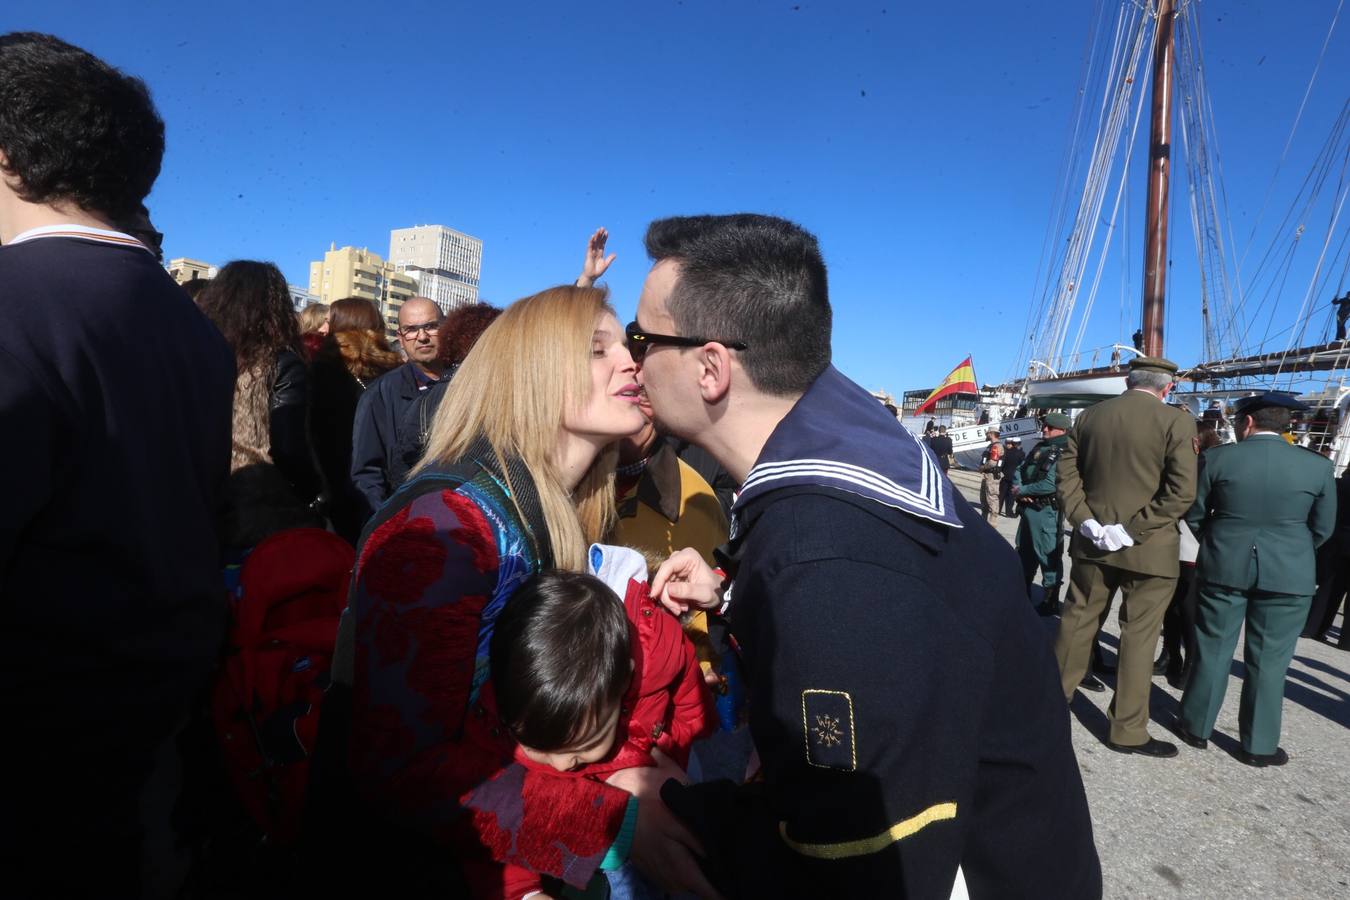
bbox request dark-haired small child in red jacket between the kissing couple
[490,544,716,897]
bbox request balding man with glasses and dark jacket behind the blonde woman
[351,297,441,511]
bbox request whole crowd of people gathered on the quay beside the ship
[0,32,1345,899]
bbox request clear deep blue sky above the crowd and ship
[13,0,1350,391]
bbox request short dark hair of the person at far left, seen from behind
[0,31,165,223]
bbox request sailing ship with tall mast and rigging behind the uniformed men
[918,0,1350,472]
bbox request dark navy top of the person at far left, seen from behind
[0,237,235,896]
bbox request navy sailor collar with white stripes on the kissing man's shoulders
[733,366,961,532]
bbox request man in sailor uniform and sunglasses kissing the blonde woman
[628,215,1102,897]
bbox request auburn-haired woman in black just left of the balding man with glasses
[310,297,402,545]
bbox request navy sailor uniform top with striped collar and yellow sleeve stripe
[663,368,1102,900]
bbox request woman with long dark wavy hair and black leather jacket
[197,259,319,546]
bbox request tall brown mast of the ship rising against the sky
[1143,0,1176,356]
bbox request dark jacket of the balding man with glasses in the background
[351,363,435,509]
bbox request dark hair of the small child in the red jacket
[490,571,632,752]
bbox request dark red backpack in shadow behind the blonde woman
[212,528,355,845]
